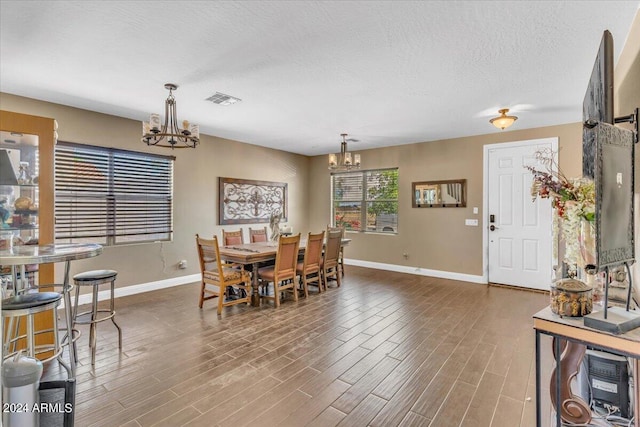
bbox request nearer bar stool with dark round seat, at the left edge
[2,292,73,378]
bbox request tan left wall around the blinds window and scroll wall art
[0,93,309,287]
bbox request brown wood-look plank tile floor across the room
[45,266,548,427]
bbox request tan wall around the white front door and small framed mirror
[309,123,582,276]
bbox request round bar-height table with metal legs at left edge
[0,243,102,377]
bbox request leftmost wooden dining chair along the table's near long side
[258,233,300,308]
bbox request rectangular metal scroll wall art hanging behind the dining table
[218,177,287,225]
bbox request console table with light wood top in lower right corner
[533,307,640,427]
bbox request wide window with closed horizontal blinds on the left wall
[55,141,175,245]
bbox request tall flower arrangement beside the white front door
[525,149,596,268]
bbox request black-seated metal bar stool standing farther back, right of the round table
[73,270,122,365]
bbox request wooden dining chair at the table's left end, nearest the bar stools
[196,234,251,314]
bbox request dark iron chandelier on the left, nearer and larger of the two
[142,83,200,149]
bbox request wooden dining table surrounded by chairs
[220,238,351,307]
